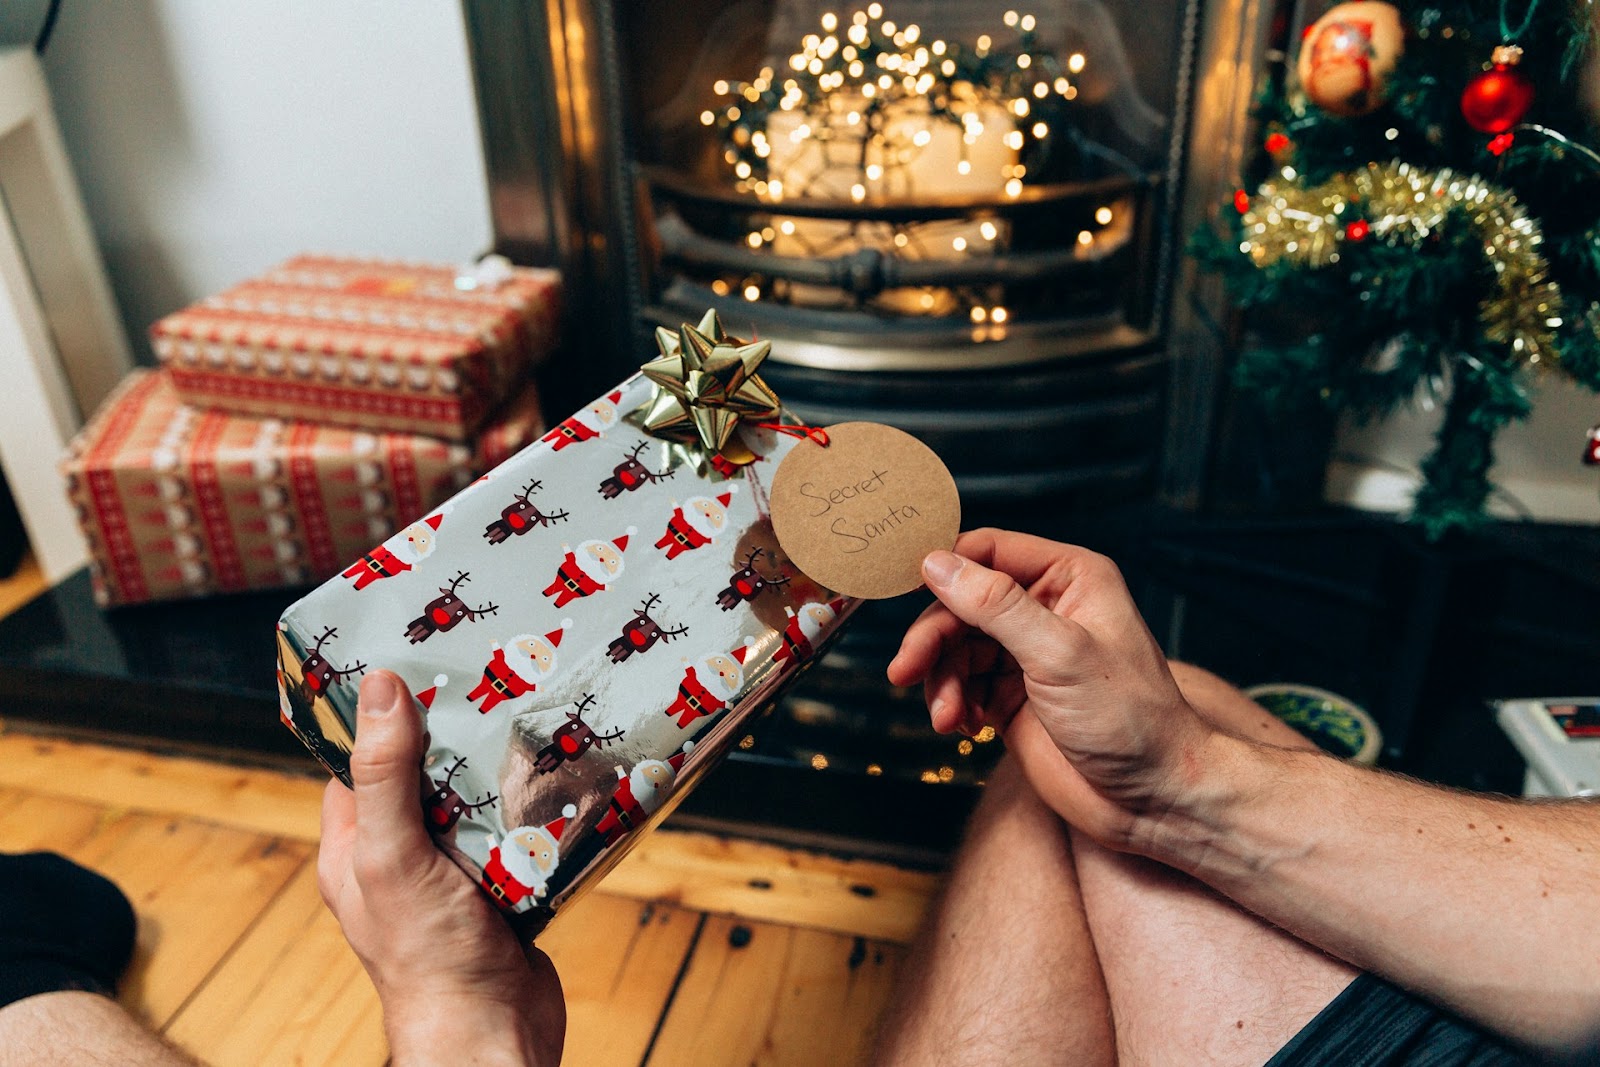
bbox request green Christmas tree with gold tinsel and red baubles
[1194,0,1600,537]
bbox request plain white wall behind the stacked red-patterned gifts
[40,0,490,363]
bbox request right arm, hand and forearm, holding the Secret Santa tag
[890,530,1600,1062]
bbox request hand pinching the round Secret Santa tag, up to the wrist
[890,530,1213,848]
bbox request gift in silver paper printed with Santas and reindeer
[278,318,858,931]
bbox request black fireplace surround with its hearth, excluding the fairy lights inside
[0,0,1600,862]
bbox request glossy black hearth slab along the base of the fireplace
[0,506,1600,865]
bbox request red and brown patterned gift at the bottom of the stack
[62,371,542,605]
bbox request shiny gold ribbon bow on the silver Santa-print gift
[640,310,779,462]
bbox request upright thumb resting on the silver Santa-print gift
[350,670,432,872]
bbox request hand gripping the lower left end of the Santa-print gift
[317,670,566,1065]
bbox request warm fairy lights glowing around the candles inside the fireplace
[699,2,1131,321]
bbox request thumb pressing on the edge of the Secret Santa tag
[922,552,1082,677]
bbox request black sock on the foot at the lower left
[0,853,134,1008]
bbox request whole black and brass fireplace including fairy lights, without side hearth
[464,0,1291,851]
